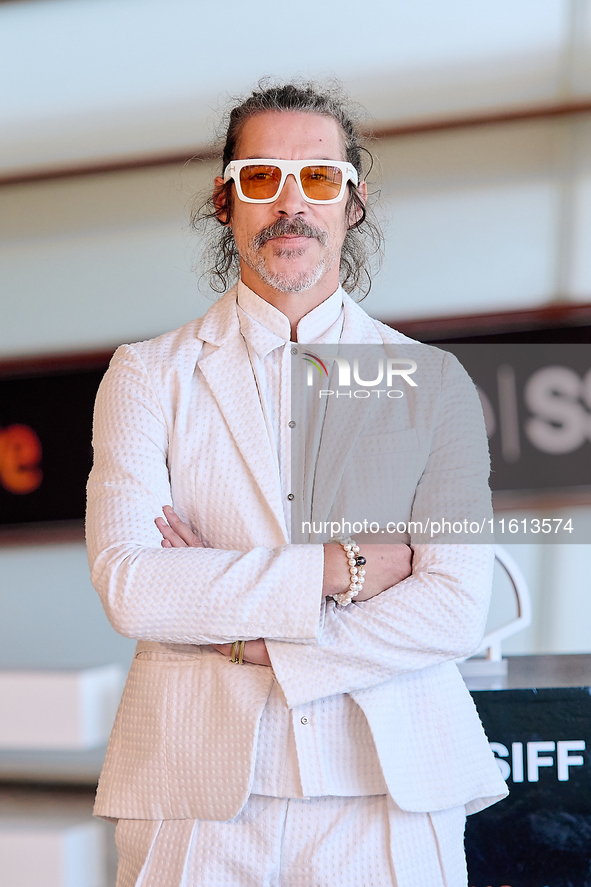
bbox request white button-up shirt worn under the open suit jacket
[238,282,387,798]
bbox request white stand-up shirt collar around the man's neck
[237,280,343,357]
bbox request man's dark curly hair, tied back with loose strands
[191,78,383,298]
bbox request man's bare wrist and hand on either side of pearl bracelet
[322,542,412,602]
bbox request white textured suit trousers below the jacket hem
[116,795,467,887]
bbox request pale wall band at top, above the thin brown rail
[0,0,572,168]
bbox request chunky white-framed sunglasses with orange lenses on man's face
[224,158,359,203]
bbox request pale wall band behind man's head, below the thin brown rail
[5,117,591,355]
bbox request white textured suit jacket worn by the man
[87,290,506,820]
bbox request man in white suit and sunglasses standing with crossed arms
[88,84,506,887]
